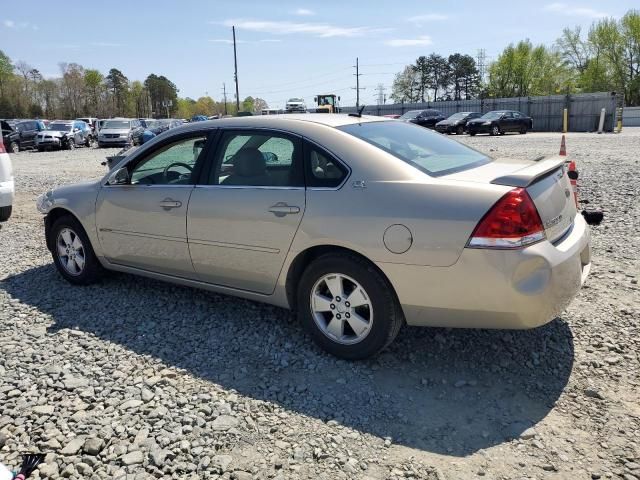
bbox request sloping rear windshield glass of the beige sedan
[338,122,491,177]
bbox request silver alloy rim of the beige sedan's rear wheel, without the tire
[310,273,373,345]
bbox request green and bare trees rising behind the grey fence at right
[391,10,640,106]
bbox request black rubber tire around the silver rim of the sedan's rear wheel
[296,253,404,360]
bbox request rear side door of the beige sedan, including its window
[187,129,305,294]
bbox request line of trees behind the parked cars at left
[0,50,267,119]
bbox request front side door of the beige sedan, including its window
[96,131,210,278]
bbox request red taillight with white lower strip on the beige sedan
[467,188,546,248]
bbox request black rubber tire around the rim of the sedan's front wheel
[47,215,104,285]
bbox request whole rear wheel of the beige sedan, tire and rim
[297,253,404,360]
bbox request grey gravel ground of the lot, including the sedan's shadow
[0,128,640,480]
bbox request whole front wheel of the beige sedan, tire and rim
[47,215,103,285]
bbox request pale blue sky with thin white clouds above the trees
[0,0,638,108]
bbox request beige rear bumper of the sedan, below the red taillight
[378,215,591,329]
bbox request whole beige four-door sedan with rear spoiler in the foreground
[37,114,591,359]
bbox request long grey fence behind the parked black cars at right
[341,92,618,132]
